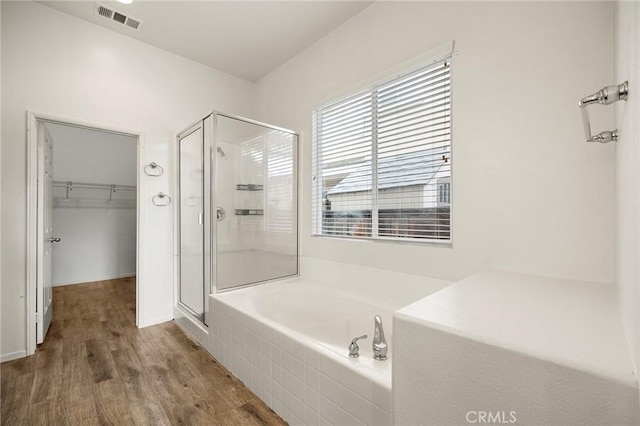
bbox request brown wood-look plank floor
[0,278,286,426]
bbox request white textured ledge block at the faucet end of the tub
[393,271,639,425]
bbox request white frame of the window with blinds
[311,41,454,247]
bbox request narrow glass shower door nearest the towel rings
[178,122,205,320]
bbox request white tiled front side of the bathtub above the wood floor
[205,297,392,425]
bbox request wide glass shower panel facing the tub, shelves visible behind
[214,114,298,291]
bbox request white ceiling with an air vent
[39,0,372,81]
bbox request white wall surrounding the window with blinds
[257,2,615,283]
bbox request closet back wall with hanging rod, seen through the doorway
[46,123,138,286]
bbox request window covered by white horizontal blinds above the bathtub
[312,54,452,241]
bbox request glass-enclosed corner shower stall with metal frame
[175,112,298,324]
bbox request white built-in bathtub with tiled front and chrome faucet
[205,262,449,425]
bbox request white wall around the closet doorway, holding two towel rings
[0,1,253,360]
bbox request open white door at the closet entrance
[36,123,55,344]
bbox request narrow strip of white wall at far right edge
[610,1,640,376]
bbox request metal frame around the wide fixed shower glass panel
[210,110,300,294]
